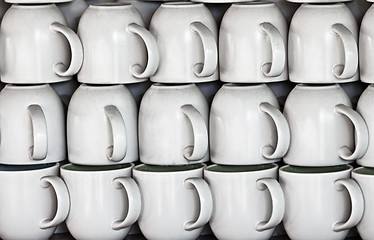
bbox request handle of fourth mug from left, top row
[260,22,286,77]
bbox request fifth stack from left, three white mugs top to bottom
[279,1,369,239]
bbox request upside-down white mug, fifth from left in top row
[288,3,359,84]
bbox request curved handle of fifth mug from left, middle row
[335,104,369,161]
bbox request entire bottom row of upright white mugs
[5,163,374,240]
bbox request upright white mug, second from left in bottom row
[61,163,141,240]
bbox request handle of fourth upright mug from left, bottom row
[256,178,285,231]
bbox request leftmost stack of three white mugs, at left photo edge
[0,0,83,239]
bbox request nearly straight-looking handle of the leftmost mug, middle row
[27,104,48,160]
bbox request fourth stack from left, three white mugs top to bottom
[204,2,290,239]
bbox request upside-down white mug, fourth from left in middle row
[209,83,290,165]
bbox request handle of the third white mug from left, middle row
[181,104,208,161]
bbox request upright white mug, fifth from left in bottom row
[279,165,364,240]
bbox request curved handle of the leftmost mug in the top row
[49,22,83,77]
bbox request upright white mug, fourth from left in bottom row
[204,164,284,239]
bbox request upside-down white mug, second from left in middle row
[66,84,138,165]
